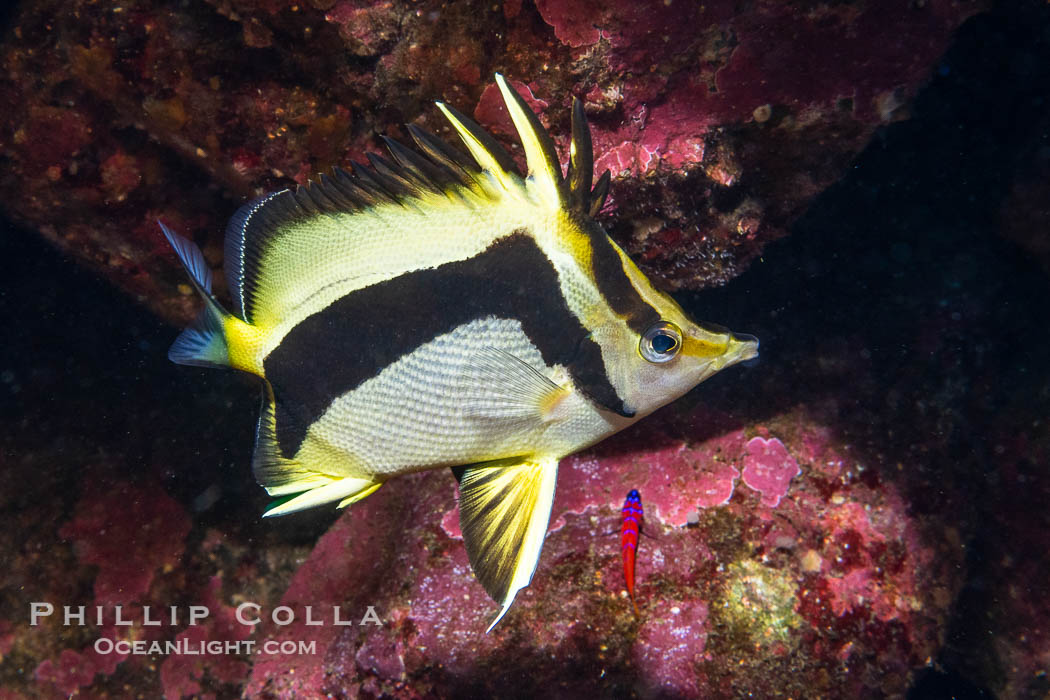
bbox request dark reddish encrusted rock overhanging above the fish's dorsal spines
[0,0,981,321]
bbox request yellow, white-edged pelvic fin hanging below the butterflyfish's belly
[453,458,558,632]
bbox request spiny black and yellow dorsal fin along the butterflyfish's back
[225,75,608,323]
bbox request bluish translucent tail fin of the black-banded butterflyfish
[158,221,230,367]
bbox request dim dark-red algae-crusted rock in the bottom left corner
[6,463,302,700]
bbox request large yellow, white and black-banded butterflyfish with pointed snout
[161,76,758,630]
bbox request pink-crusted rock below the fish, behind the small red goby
[247,407,961,698]
